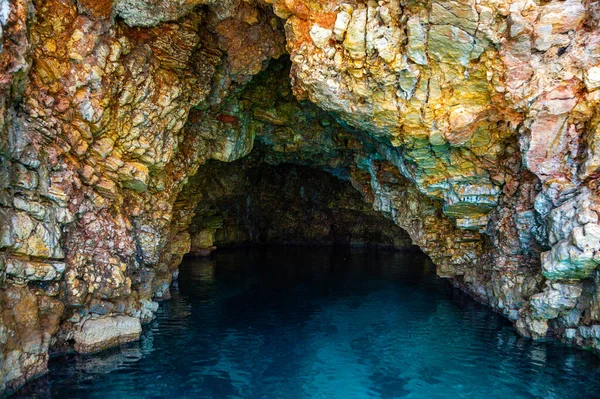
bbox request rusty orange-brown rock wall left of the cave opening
[0,0,284,391]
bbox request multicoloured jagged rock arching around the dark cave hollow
[0,0,600,391]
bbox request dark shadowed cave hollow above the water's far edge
[179,156,417,256]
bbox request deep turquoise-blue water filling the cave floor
[12,247,600,399]
